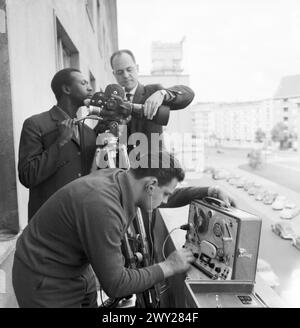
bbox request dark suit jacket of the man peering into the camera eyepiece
[18,106,96,219]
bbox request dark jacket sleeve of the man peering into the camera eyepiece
[18,119,64,188]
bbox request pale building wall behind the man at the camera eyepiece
[1,0,118,228]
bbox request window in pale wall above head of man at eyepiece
[56,18,79,70]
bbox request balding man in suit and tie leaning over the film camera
[110,49,194,154]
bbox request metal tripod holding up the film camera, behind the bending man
[94,122,160,308]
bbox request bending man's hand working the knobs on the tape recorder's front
[159,248,196,278]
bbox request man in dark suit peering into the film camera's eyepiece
[18,68,96,220]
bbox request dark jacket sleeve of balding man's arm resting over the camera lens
[164,85,195,110]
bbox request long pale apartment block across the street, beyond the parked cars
[192,99,274,147]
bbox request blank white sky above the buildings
[117,0,300,102]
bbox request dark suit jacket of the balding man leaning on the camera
[127,83,194,151]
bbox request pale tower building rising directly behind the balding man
[139,38,204,171]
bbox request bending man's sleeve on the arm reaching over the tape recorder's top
[160,187,208,208]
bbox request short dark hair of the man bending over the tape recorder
[131,151,185,186]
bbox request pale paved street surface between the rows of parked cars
[186,149,300,307]
